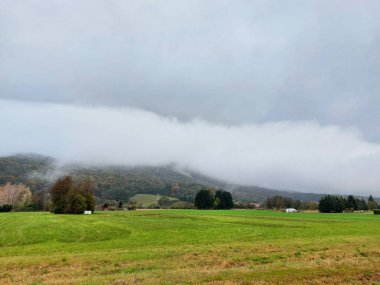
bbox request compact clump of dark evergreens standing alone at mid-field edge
[194,189,234,209]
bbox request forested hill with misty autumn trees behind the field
[0,154,362,201]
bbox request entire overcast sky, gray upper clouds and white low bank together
[0,0,380,195]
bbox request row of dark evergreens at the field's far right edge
[319,195,378,213]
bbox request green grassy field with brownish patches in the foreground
[0,210,380,284]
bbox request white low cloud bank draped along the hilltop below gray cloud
[0,100,380,195]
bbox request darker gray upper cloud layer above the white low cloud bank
[0,0,380,142]
